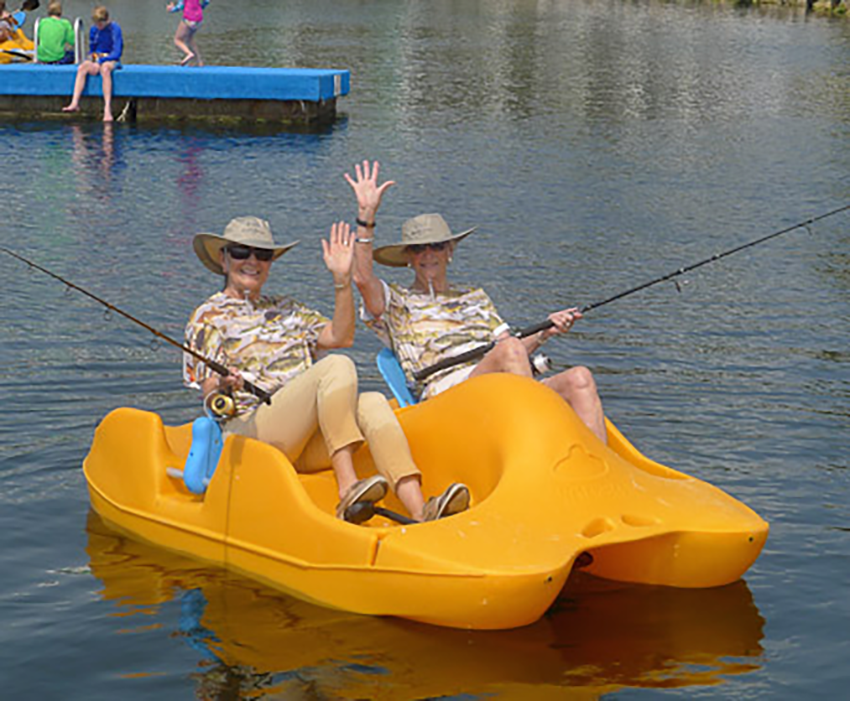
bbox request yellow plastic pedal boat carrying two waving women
[83,374,768,629]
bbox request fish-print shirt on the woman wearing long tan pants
[183,292,329,414]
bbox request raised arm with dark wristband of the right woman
[345,161,395,319]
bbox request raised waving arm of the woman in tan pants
[317,221,354,350]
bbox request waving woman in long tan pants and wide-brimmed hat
[183,217,469,521]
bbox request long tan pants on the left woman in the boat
[224,355,420,490]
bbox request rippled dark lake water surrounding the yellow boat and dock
[0,0,850,701]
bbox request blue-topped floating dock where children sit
[0,64,350,123]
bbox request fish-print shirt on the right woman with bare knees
[360,280,508,399]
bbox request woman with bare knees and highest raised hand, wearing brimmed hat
[345,161,607,442]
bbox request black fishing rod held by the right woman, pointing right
[413,204,850,382]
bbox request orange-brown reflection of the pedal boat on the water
[87,511,764,699]
